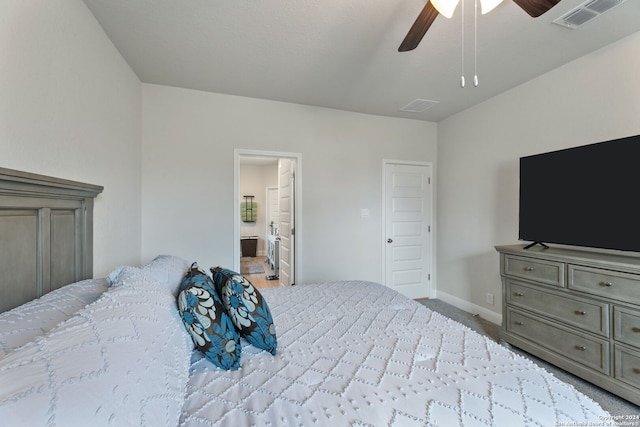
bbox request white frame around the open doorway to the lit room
[233,148,303,283]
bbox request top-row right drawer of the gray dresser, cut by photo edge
[568,264,640,303]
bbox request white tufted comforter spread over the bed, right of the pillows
[181,281,607,427]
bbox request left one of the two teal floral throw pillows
[178,263,241,370]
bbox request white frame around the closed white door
[380,159,437,298]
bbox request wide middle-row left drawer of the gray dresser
[506,279,608,337]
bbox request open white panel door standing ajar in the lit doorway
[278,159,295,286]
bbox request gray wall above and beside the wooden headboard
[0,0,141,276]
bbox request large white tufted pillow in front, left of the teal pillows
[0,267,191,426]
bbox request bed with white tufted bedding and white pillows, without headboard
[0,169,610,426]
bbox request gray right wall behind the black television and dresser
[437,33,640,320]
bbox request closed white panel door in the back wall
[384,163,432,298]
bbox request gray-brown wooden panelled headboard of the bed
[0,168,103,312]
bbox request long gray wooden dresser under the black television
[496,245,640,405]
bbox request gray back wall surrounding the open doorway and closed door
[142,84,437,283]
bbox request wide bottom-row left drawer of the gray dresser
[507,307,610,375]
